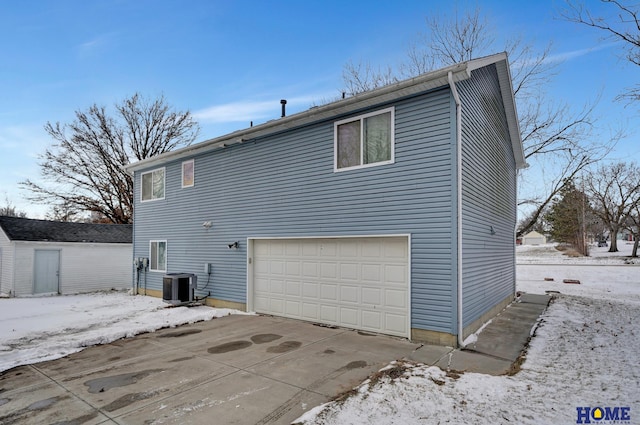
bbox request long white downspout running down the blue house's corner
[447,71,464,347]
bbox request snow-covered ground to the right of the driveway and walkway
[299,242,640,425]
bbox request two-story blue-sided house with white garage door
[127,54,526,345]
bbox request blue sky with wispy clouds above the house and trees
[0,0,640,218]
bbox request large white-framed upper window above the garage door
[334,107,394,171]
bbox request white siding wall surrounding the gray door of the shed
[10,242,133,296]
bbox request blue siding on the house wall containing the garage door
[134,89,456,333]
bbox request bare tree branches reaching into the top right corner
[560,0,640,100]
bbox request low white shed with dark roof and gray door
[0,216,132,297]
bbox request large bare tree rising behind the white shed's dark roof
[20,93,199,223]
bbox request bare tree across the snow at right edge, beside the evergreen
[584,162,640,252]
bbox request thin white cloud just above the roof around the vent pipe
[193,96,328,123]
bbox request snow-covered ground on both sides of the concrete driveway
[0,242,640,425]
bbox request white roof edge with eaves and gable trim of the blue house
[125,53,527,173]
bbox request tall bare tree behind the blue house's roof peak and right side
[343,8,620,236]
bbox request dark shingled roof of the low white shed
[0,216,132,243]
